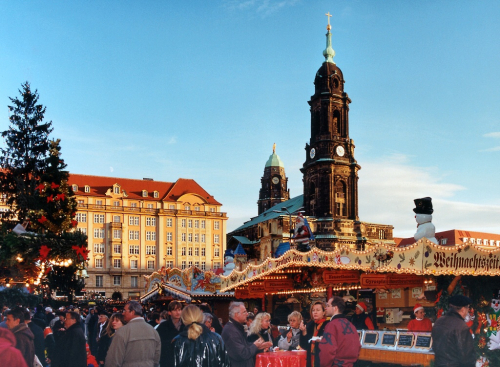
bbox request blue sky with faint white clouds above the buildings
[0,0,500,236]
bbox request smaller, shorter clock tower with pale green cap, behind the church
[257,144,290,215]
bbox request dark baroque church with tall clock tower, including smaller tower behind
[227,20,395,261]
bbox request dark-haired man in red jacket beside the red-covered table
[319,297,361,367]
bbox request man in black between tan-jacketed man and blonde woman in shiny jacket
[156,301,185,367]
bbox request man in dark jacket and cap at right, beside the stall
[432,295,476,367]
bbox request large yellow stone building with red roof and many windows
[69,174,227,299]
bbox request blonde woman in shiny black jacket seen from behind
[172,305,229,367]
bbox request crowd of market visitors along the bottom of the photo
[0,296,473,367]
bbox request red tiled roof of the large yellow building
[68,173,222,205]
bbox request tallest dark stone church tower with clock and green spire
[301,14,361,223]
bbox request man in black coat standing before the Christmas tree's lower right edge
[51,311,87,367]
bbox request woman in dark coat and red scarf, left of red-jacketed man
[299,301,327,367]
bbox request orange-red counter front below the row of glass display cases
[358,348,434,367]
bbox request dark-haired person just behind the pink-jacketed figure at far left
[7,307,35,367]
